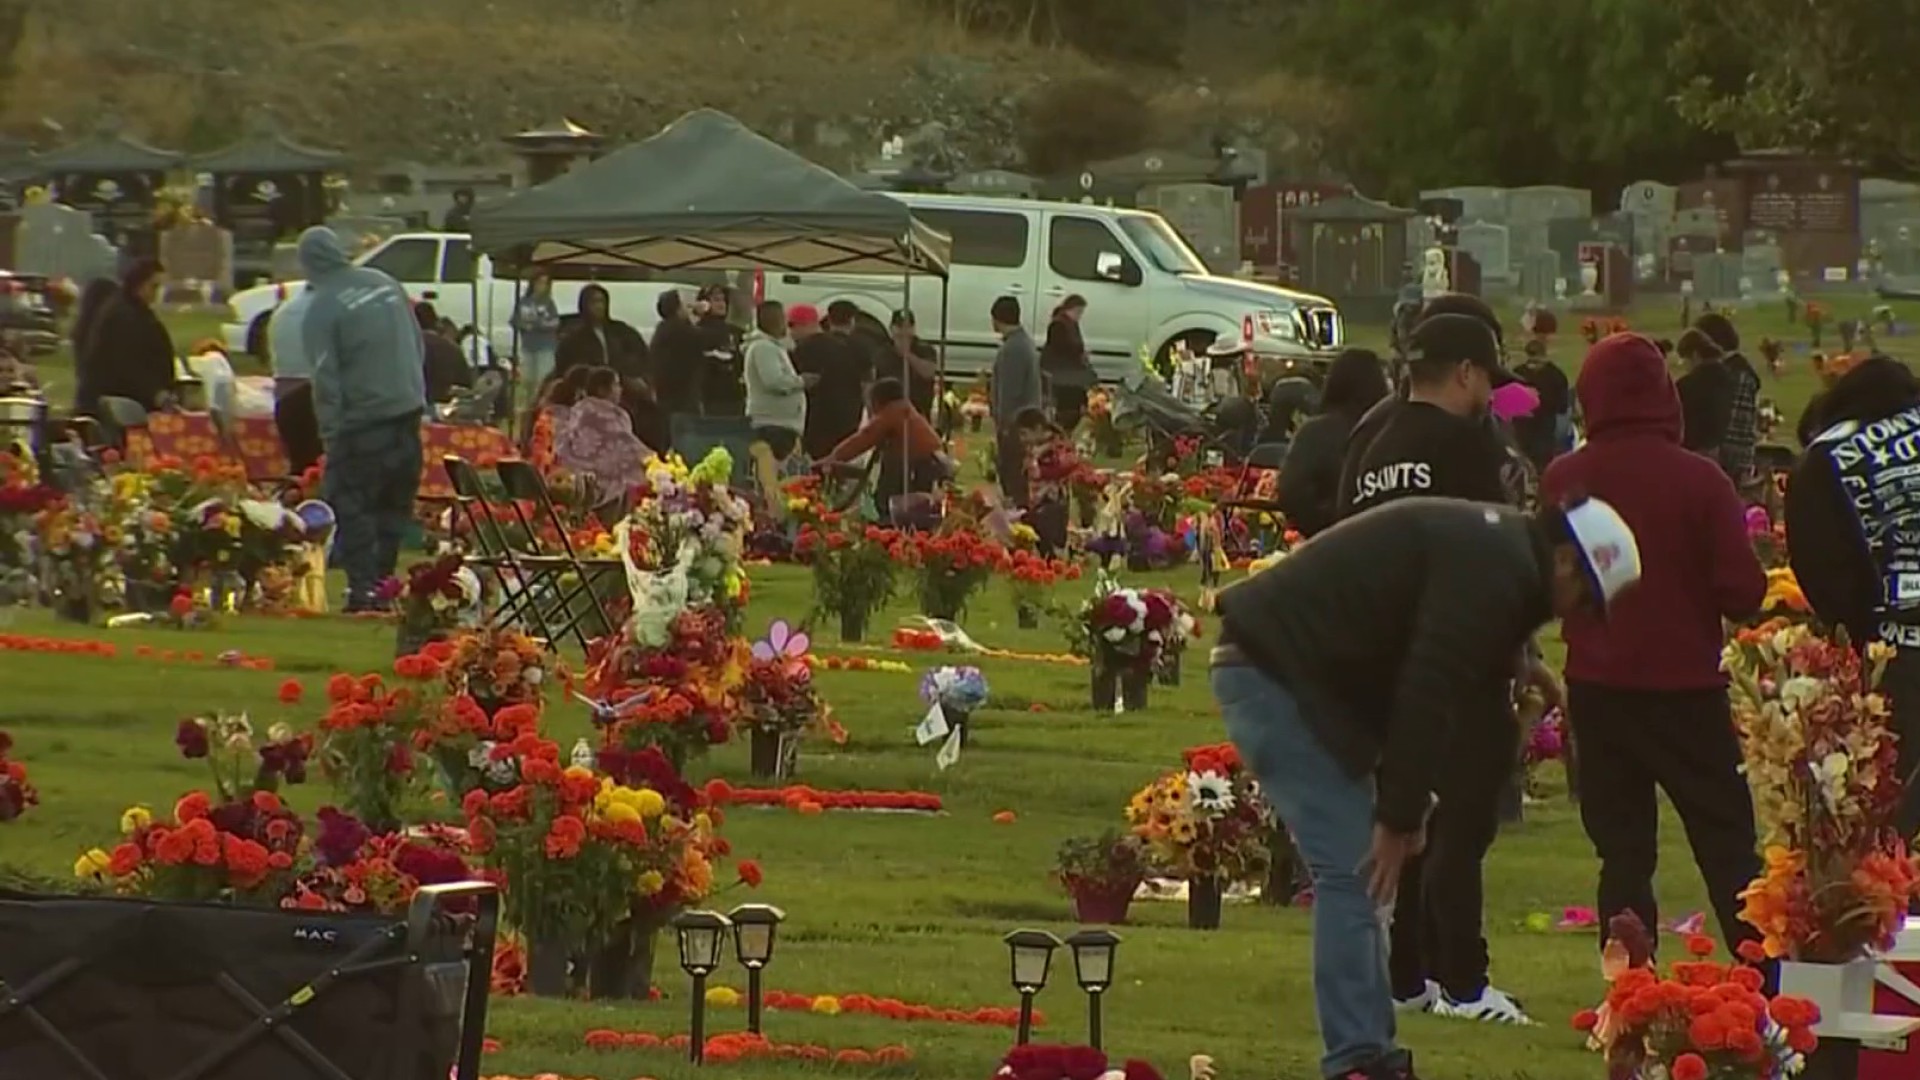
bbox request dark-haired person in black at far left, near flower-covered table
[73,259,177,417]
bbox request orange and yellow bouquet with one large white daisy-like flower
[1127,744,1273,905]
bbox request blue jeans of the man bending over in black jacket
[1212,667,1409,1076]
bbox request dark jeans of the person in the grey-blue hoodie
[323,413,422,611]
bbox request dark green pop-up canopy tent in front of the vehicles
[472,110,952,499]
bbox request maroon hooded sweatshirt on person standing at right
[1542,334,1766,690]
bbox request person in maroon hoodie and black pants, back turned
[1542,334,1766,945]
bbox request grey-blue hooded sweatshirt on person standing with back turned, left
[300,225,426,442]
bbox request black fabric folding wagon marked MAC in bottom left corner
[0,882,499,1080]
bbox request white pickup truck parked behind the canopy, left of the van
[221,233,695,357]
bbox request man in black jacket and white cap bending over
[1212,498,1640,1080]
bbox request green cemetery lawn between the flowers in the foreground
[11,567,1705,1080]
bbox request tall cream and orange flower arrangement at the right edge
[1722,625,1920,963]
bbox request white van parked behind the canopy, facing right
[766,194,1346,380]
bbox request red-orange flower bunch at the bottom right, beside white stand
[1572,913,1820,1080]
